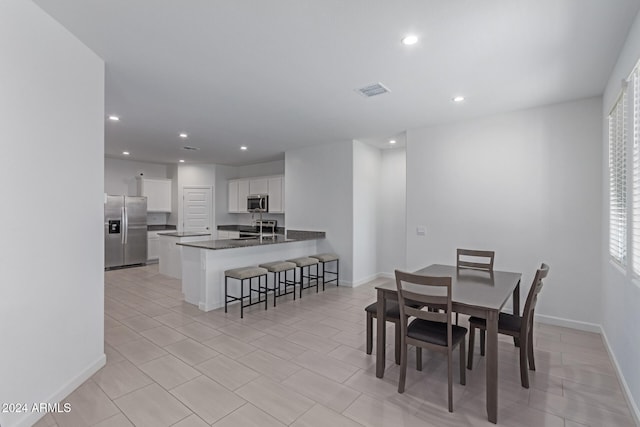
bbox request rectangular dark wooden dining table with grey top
[376,264,522,424]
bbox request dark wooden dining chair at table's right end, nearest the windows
[467,263,549,388]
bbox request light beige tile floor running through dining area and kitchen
[36,265,635,427]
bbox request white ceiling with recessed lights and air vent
[35,0,640,165]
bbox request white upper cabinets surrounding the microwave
[227,175,284,213]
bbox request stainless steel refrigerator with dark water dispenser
[104,196,147,268]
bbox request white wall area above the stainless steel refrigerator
[104,157,168,196]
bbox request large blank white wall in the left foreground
[0,0,105,427]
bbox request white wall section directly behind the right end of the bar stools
[285,141,353,284]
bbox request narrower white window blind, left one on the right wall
[609,90,627,265]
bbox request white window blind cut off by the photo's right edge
[630,66,640,276]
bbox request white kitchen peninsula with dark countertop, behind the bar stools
[178,230,325,311]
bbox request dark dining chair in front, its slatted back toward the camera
[395,270,467,412]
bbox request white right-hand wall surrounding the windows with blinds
[601,8,640,420]
